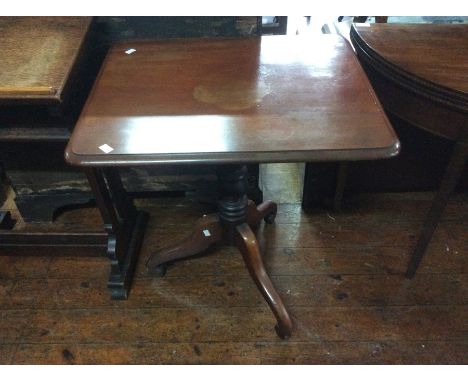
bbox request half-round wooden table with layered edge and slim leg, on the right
[351,24,468,278]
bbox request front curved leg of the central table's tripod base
[236,223,292,338]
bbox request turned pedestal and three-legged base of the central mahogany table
[147,165,292,338]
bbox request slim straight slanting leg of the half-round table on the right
[405,142,468,278]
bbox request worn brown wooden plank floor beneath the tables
[0,163,468,364]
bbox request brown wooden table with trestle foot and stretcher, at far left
[0,17,149,298]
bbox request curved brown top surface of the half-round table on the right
[351,24,468,112]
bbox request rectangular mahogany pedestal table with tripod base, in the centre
[66,35,399,338]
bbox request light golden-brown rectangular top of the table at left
[0,17,92,103]
